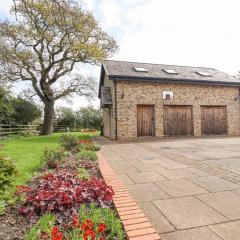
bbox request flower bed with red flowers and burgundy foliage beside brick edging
[0,134,126,240]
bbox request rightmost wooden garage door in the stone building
[201,106,227,135]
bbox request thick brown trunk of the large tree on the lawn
[41,101,54,135]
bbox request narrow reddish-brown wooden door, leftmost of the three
[137,105,154,137]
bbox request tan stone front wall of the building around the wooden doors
[112,81,240,140]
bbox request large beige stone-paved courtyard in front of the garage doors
[99,138,240,240]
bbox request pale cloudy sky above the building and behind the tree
[0,0,240,109]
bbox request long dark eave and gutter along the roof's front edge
[108,75,240,87]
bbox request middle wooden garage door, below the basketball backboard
[163,106,193,136]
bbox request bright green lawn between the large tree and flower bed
[0,132,98,185]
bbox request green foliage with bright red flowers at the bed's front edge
[26,204,126,240]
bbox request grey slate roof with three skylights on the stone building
[102,60,240,86]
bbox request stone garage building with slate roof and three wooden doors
[99,60,240,140]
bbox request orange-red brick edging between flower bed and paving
[97,152,160,240]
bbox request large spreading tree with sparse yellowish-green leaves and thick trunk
[0,0,118,135]
